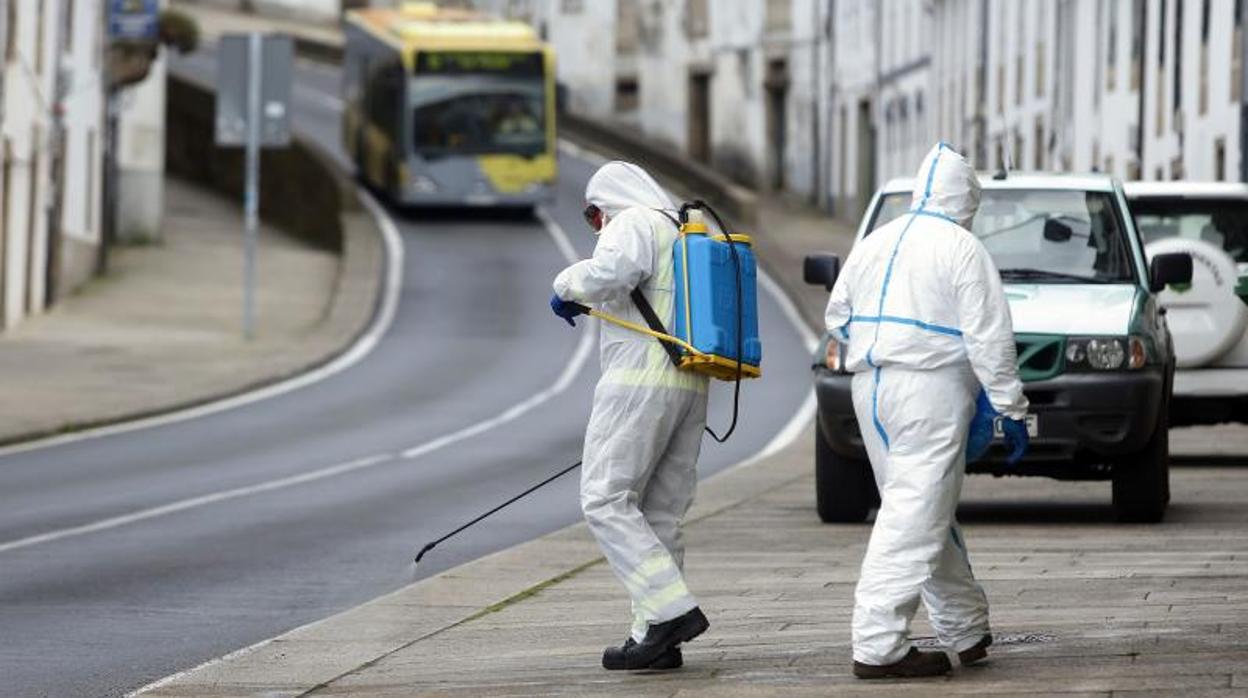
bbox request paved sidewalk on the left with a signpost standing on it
[0,180,382,443]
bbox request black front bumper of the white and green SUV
[815,366,1166,478]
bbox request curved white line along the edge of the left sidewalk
[0,189,403,458]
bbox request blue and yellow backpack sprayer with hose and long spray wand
[416,201,763,564]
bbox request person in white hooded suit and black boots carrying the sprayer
[550,162,708,669]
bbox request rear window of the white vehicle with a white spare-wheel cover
[1129,196,1248,263]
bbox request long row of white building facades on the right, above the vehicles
[501,0,1243,219]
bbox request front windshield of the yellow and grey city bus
[409,51,547,157]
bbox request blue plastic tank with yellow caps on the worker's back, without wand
[673,209,763,381]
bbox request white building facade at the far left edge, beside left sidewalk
[0,0,104,328]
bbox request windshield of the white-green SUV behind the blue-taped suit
[870,189,1136,283]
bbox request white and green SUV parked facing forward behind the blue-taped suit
[805,174,1192,522]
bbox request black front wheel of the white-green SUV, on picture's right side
[1113,412,1169,523]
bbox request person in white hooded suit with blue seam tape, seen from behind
[825,144,1027,678]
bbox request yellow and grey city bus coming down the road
[342,2,558,207]
